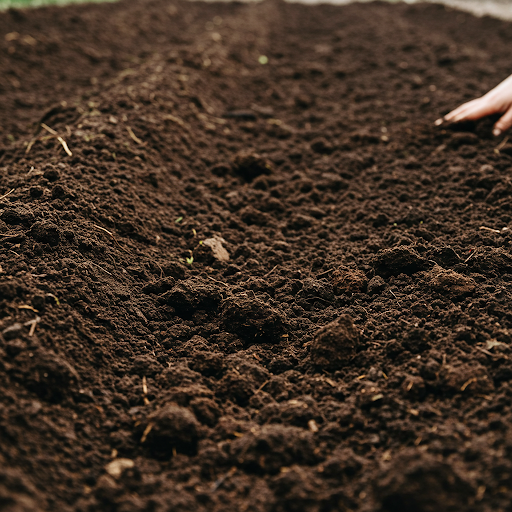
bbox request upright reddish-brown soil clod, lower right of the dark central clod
[311,315,359,369]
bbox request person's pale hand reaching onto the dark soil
[436,75,512,136]
